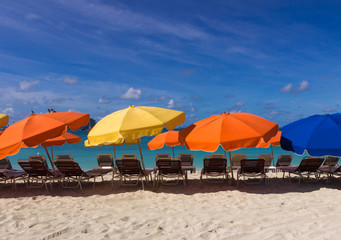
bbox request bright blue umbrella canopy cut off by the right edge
[281,113,341,156]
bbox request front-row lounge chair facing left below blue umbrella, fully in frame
[281,157,324,182]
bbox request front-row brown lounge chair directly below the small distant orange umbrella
[155,158,187,188]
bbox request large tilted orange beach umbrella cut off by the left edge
[0,112,90,167]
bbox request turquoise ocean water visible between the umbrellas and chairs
[9,130,306,170]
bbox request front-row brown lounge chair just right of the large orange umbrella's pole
[237,158,267,186]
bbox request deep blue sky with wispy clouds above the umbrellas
[0,0,341,126]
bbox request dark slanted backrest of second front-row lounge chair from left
[18,159,51,177]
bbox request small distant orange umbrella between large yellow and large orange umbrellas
[148,131,181,158]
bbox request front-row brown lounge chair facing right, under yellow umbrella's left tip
[53,155,107,190]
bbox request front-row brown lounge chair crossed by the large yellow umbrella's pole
[116,158,153,190]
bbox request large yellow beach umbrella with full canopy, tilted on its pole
[88,105,185,169]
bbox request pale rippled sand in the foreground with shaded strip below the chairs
[0,175,341,239]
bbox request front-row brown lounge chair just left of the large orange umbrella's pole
[200,155,228,183]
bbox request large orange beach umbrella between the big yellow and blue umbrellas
[179,113,278,177]
